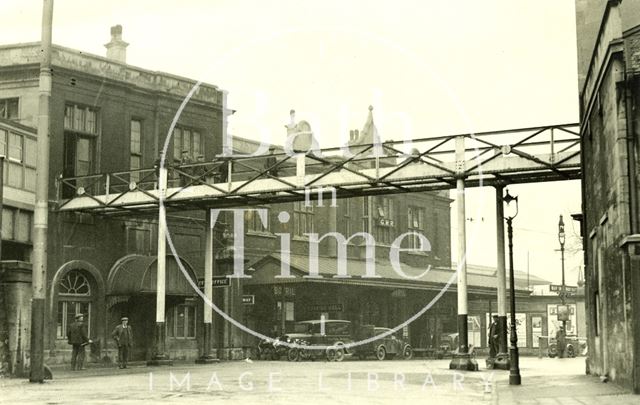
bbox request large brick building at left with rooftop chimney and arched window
[0,26,224,372]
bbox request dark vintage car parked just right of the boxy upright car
[354,325,413,360]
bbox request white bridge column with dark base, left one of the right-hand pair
[449,136,478,371]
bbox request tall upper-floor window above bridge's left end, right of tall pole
[63,105,98,197]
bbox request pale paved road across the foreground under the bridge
[0,358,640,405]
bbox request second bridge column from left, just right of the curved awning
[196,209,218,364]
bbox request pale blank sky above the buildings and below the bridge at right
[0,0,581,285]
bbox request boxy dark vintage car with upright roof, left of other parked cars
[284,319,353,361]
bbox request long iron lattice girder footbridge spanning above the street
[57,124,580,215]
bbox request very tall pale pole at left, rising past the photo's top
[29,0,53,383]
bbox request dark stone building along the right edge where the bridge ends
[576,0,640,393]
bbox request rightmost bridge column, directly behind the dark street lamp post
[493,186,510,370]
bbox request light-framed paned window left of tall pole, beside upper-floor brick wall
[0,130,37,191]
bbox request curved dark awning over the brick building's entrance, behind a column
[107,255,198,296]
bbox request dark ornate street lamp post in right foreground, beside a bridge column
[502,190,521,385]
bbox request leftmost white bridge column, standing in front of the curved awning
[147,167,173,366]
